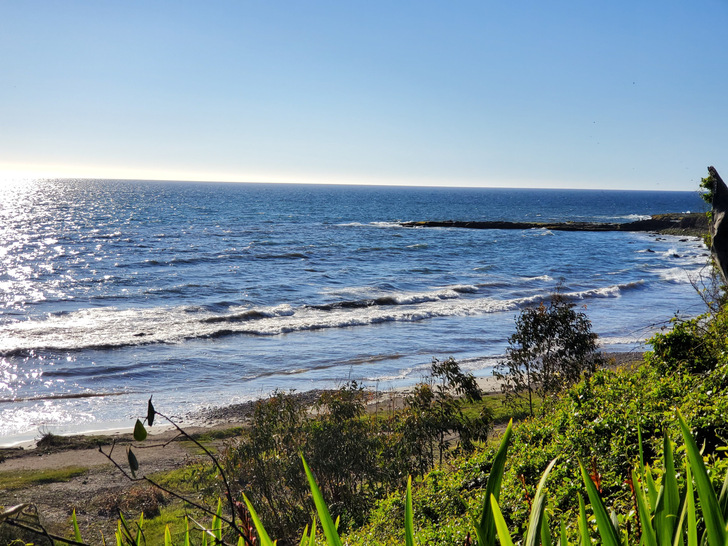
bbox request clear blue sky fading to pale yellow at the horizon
[0,0,728,190]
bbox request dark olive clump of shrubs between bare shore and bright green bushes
[221,358,492,537]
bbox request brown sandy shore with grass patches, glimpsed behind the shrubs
[0,351,643,536]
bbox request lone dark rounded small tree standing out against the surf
[494,290,603,416]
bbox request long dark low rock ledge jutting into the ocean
[400,211,708,236]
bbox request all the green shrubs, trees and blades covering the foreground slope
[0,186,728,546]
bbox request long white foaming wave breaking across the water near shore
[0,281,643,356]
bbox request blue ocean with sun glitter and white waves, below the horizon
[0,180,709,445]
